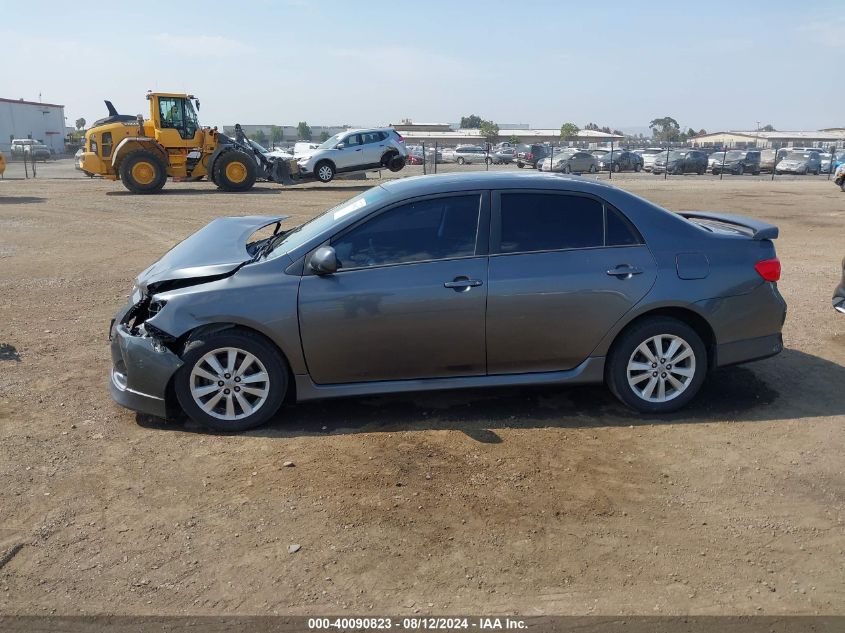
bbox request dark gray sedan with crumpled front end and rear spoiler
[110,172,786,431]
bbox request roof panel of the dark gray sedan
[381,171,616,198]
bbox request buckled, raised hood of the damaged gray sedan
[136,215,290,292]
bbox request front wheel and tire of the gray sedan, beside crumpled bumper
[174,328,288,432]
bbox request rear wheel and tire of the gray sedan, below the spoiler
[605,317,707,413]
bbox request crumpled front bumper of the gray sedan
[109,306,182,418]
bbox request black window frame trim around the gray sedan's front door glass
[302,189,490,275]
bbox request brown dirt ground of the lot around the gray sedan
[0,161,845,615]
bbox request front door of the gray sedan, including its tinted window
[299,193,489,384]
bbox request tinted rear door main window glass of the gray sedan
[499,193,604,253]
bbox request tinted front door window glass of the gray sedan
[332,195,481,268]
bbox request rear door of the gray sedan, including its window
[487,191,657,374]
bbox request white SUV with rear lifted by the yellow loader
[296,127,408,182]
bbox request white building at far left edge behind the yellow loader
[0,98,65,154]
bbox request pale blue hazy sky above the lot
[0,0,845,132]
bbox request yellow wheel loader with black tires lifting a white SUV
[79,92,299,193]
